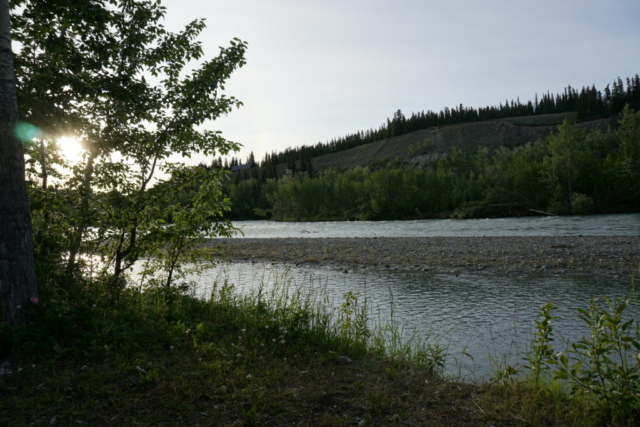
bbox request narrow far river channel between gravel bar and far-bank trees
[233,214,640,238]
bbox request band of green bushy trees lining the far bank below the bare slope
[225,106,640,221]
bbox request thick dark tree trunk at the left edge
[0,0,37,323]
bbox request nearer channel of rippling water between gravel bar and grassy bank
[182,263,639,379]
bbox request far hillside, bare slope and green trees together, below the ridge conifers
[227,107,640,221]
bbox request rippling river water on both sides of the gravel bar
[192,214,640,380]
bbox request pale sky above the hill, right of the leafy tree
[162,0,640,165]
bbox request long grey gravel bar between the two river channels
[207,236,640,279]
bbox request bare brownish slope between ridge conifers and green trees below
[278,113,616,176]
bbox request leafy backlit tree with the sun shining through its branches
[13,0,247,295]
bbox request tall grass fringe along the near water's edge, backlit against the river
[202,271,447,375]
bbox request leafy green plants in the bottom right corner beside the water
[485,298,640,426]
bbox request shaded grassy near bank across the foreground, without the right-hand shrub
[0,272,640,426]
